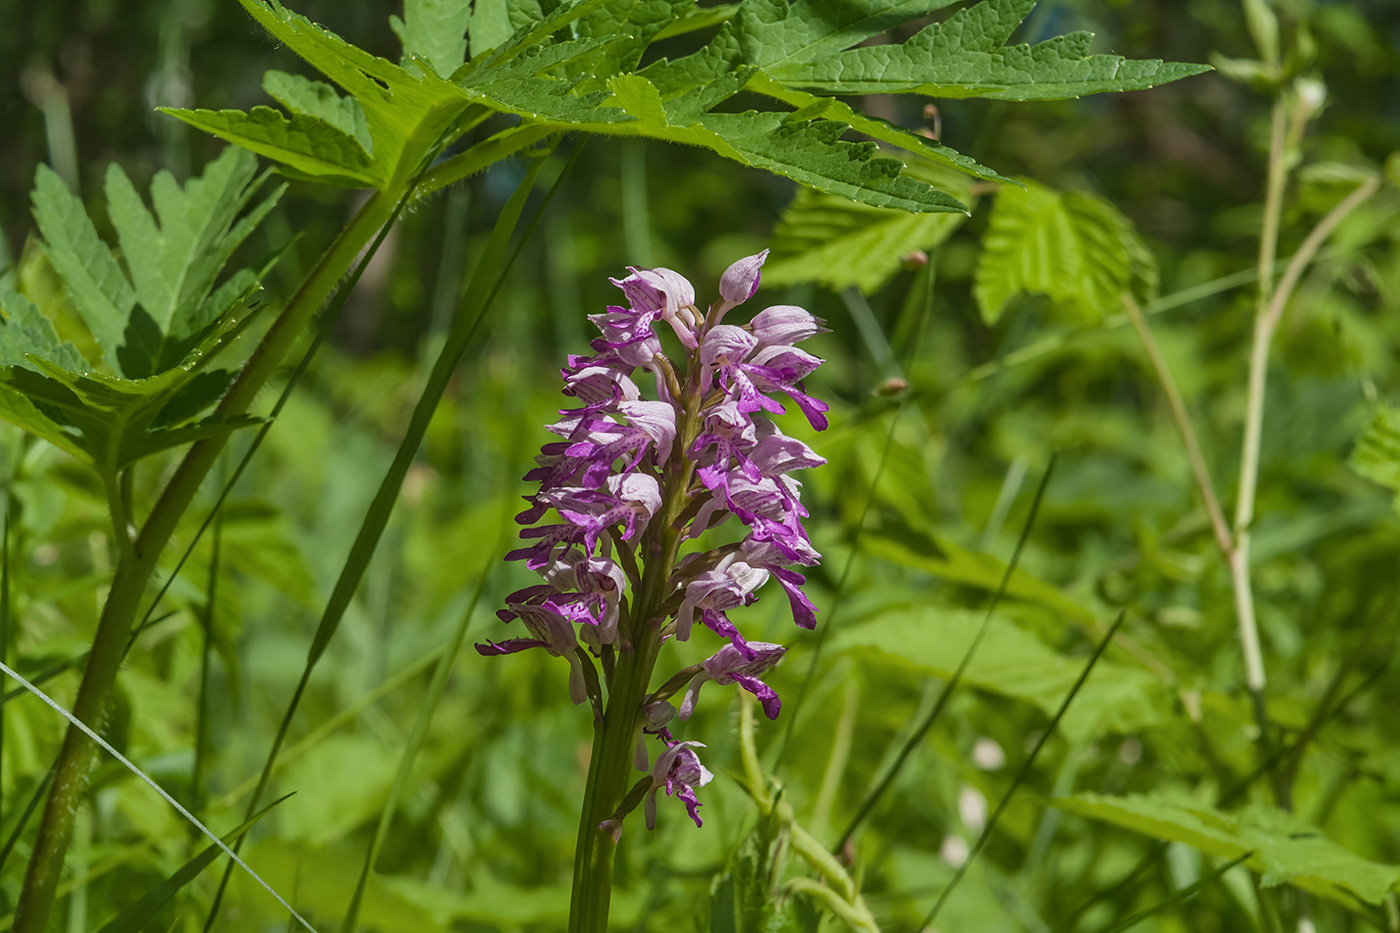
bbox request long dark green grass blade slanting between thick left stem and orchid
[204,137,582,933]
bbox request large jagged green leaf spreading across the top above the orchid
[168,0,1201,212]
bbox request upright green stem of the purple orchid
[568,350,700,933]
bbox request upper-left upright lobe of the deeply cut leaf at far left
[32,165,136,366]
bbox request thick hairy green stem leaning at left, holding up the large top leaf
[14,192,400,933]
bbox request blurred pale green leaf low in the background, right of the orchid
[832,605,1170,744]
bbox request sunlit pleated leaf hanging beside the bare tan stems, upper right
[973,182,1158,324]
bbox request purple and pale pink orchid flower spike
[476,251,827,828]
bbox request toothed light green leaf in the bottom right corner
[1054,794,1400,905]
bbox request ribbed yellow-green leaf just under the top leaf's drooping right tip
[763,161,969,294]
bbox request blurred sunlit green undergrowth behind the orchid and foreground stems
[0,0,1400,933]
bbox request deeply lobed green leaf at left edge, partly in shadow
[0,147,283,472]
